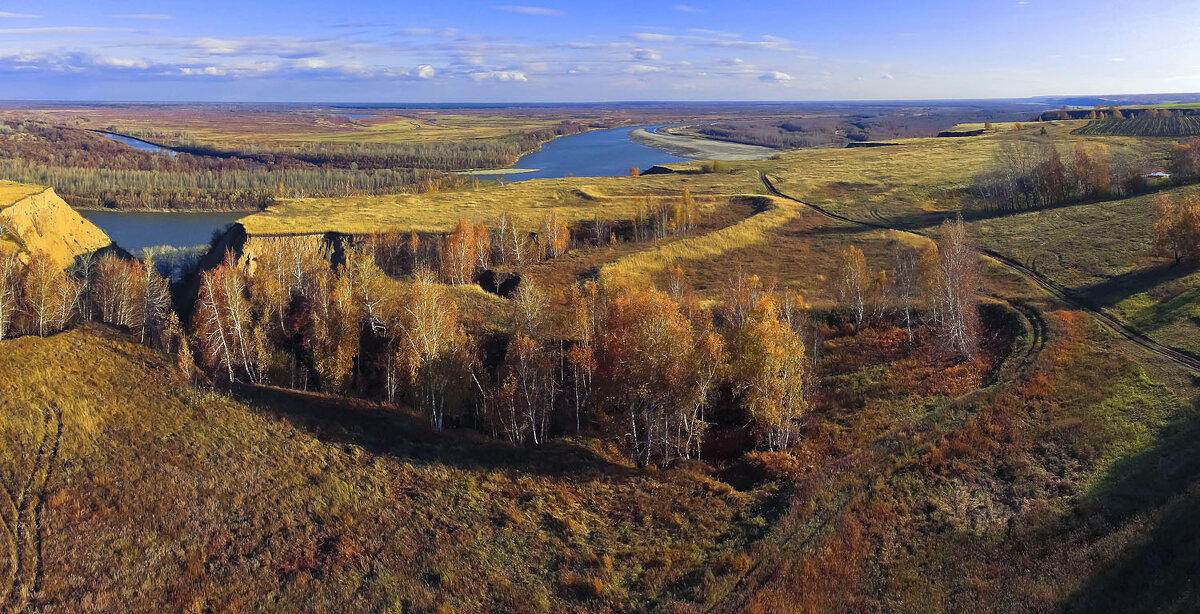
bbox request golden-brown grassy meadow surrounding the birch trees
[0,107,1200,613]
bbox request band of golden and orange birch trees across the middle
[0,199,978,465]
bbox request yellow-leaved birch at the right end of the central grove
[731,294,808,450]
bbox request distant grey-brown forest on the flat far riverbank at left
[0,120,587,211]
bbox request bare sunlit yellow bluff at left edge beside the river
[0,181,113,266]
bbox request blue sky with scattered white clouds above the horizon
[0,0,1200,102]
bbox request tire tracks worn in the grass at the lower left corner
[2,405,62,613]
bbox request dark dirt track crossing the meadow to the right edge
[760,173,1200,371]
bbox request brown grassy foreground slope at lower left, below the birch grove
[0,329,768,612]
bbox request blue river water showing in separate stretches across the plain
[79,126,686,253]
